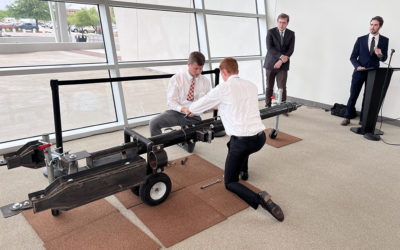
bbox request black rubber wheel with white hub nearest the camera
[139,173,171,206]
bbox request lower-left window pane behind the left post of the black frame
[0,71,116,142]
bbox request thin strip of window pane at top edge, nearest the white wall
[204,0,257,13]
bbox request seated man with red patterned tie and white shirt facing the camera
[150,51,211,153]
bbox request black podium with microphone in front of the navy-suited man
[350,68,400,141]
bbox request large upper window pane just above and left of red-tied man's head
[113,7,198,61]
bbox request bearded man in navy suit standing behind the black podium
[341,16,389,126]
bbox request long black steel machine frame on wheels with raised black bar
[0,69,299,217]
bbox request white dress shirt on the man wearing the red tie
[167,70,211,112]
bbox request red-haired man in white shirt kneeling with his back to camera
[188,57,284,221]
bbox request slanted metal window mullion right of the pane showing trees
[99,4,128,126]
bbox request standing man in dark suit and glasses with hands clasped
[264,13,295,107]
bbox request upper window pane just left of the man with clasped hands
[207,15,260,57]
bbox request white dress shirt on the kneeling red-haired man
[189,75,265,136]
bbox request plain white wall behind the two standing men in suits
[264,0,400,118]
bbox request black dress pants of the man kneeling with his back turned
[224,131,266,209]
